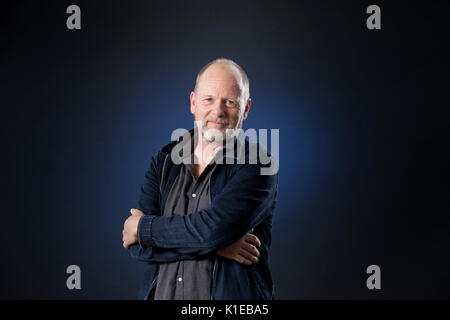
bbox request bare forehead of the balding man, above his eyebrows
[197,65,241,96]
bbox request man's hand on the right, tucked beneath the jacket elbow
[217,229,261,266]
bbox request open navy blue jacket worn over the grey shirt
[130,136,278,300]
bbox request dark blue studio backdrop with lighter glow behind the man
[0,1,450,299]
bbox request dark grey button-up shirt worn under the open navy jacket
[154,154,216,300]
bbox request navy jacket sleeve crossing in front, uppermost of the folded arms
[138,164,278,255]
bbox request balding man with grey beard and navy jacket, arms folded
[123,59,278,300]
